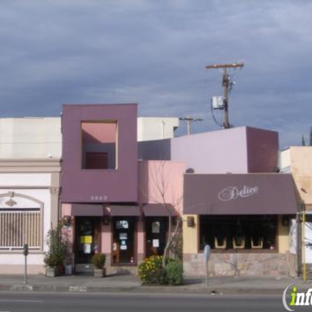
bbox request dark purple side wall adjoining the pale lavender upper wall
[247,127,278,172]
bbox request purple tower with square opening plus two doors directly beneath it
[62,104,140,272]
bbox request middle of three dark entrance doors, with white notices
[112,217,135,264]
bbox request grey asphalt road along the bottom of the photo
[0,292,285,312]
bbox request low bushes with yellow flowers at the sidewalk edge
[138,256,183,285]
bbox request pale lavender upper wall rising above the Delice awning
[171,127,248,173]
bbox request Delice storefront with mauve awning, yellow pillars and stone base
[183,173,298,276]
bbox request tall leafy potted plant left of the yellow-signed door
[44,224,67,276]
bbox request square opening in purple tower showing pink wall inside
[81,121,117,169]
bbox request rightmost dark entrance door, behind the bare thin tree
[145,217,168,257]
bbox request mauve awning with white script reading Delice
[183,173,297,215]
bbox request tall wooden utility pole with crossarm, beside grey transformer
[206,63,244,129]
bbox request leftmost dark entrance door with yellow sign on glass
[75,217,100,264]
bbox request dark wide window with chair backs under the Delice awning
[200,215,277,250]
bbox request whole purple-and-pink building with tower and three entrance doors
[62,104,185,273]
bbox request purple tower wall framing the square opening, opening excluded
[62,104,138,203]
